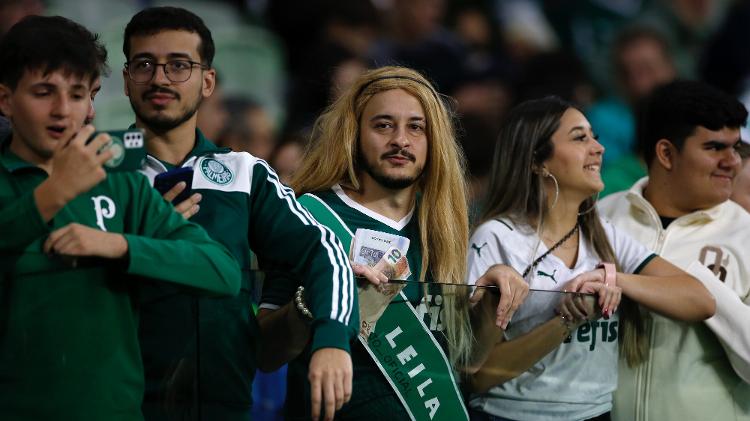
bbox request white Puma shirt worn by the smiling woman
[467,219,655,420]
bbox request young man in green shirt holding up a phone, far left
[0,16,240,420]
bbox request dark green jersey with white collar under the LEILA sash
[261,185,446,420]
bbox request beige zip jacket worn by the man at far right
[600,178,750,421]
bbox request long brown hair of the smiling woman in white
[482,97,648,366]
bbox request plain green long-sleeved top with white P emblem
[0,142,240,420]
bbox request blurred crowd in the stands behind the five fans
[0,0,750,416]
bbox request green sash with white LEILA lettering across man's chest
[299,194,469,421]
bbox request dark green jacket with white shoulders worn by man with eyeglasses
[140,131,359,421]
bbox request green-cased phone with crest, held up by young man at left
[86,129,146,172]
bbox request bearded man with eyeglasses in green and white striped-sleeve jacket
[123,7,359,420]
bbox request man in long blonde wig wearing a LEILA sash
[259,67,528,420]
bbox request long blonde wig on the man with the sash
[290,67,473,364]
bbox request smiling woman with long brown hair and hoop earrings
[468,97,714,421]
